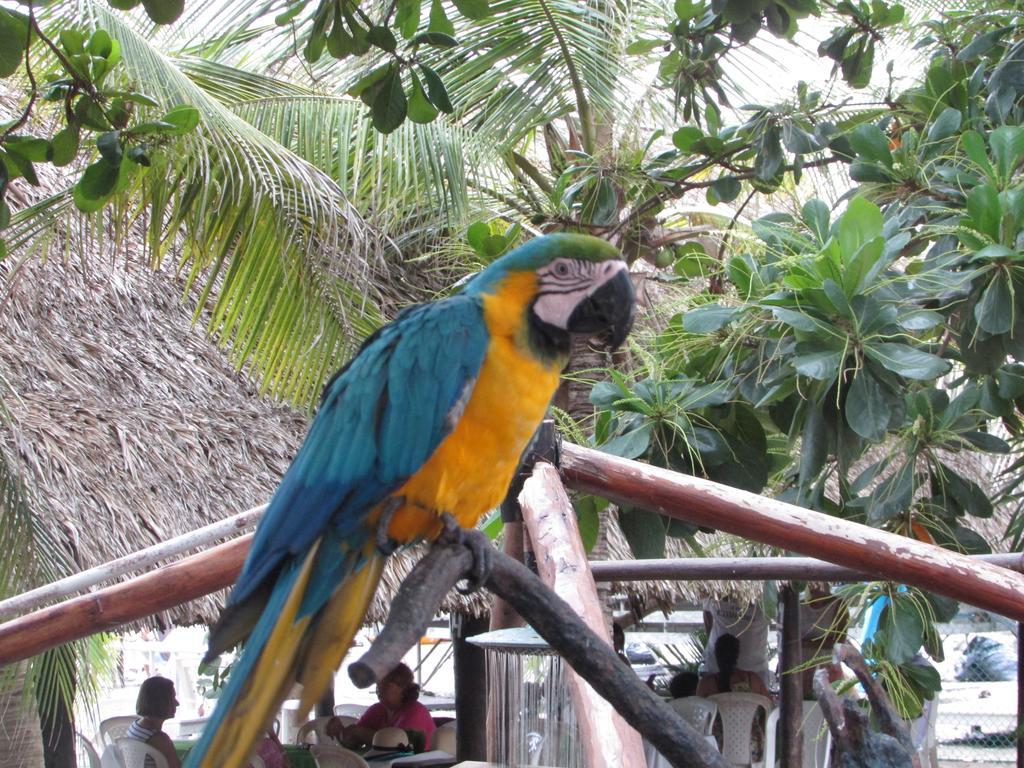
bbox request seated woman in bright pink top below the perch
[325,664,436,750]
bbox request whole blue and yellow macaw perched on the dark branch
[185,233,634,768]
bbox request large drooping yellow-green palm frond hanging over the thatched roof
[25,4,386,404]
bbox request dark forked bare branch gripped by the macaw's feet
[348,531,729,768]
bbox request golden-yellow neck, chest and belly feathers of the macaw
[389,273,563,541]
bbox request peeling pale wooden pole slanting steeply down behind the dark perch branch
[519,462,644,768]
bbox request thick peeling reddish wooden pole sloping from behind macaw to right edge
[562,442,1024,622]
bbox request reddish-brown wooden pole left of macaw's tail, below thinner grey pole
[0,534,253,667]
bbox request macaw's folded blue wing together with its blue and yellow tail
[186,295,488,768]
